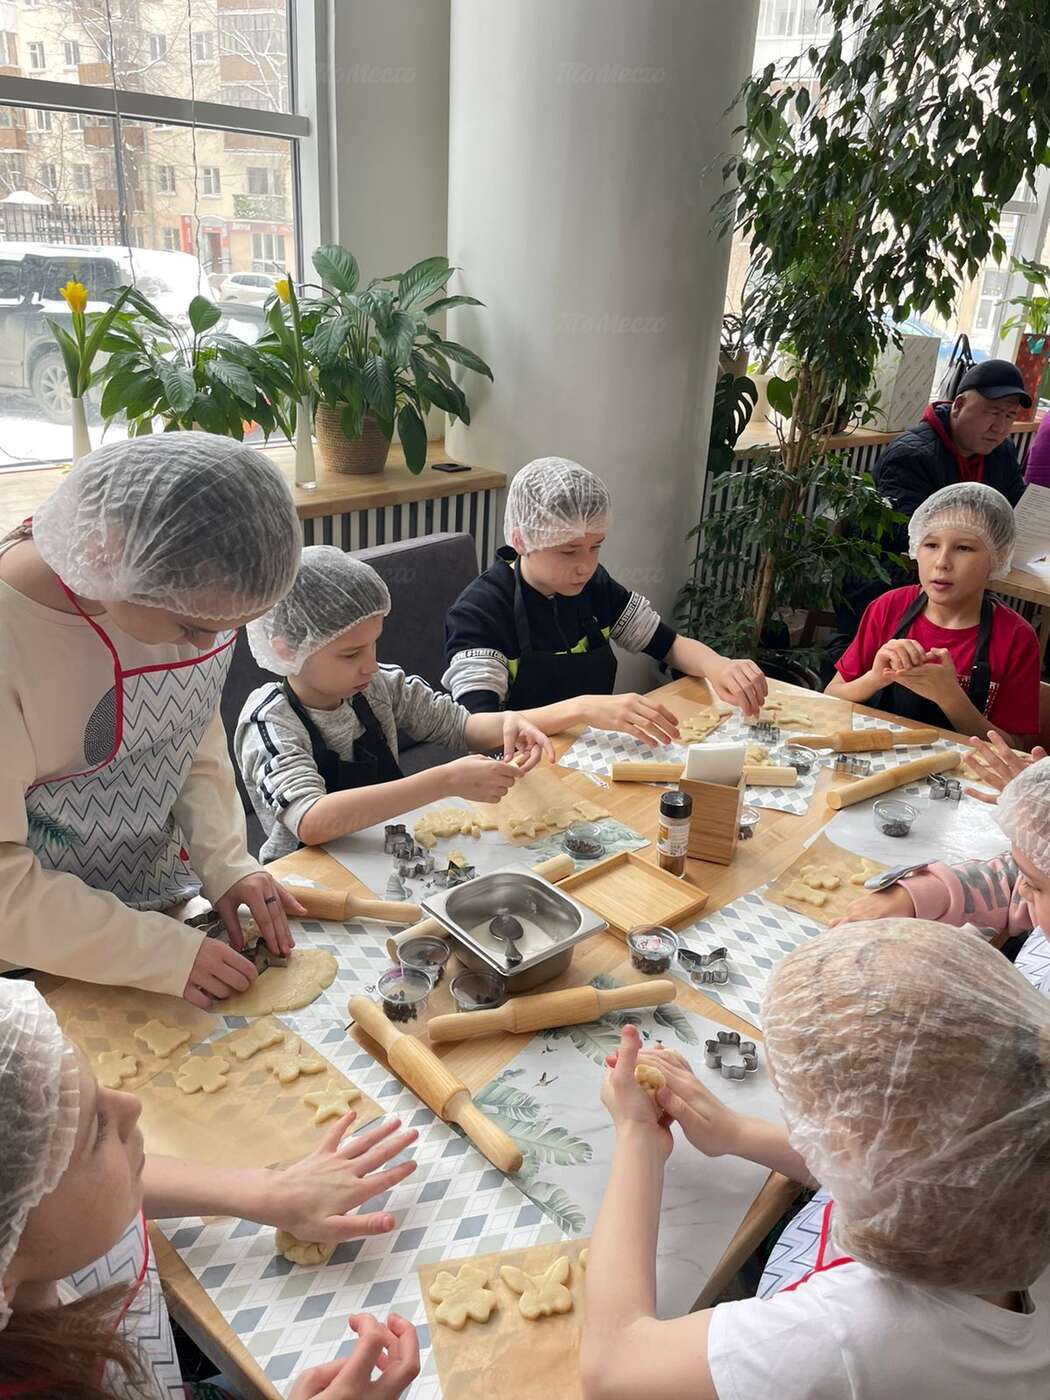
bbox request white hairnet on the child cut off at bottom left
[0,979,80,1331]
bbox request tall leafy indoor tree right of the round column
[687,0,1050,677]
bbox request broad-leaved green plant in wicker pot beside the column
[267,244,493,475]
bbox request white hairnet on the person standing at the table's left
[32,433,302,622]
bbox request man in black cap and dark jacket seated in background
[825,360,1032,669]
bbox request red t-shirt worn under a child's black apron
[836,584,1040,734]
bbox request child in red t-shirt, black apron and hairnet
[826,482,1039,746]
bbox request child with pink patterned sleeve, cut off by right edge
[841,757,1050,997]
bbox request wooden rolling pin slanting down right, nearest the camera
[347,997,521,1173]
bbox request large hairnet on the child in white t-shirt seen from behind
[762,918,1050,1294]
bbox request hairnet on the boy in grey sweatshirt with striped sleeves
[246,545,391,676]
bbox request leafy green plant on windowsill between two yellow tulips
[101,288,294,441]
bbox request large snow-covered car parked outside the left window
[0,242,207,423]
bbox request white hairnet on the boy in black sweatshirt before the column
[503,456,612,553]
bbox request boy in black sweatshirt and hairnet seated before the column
[442,456,766,745]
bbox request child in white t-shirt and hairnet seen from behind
[580,920,1050,1400]
